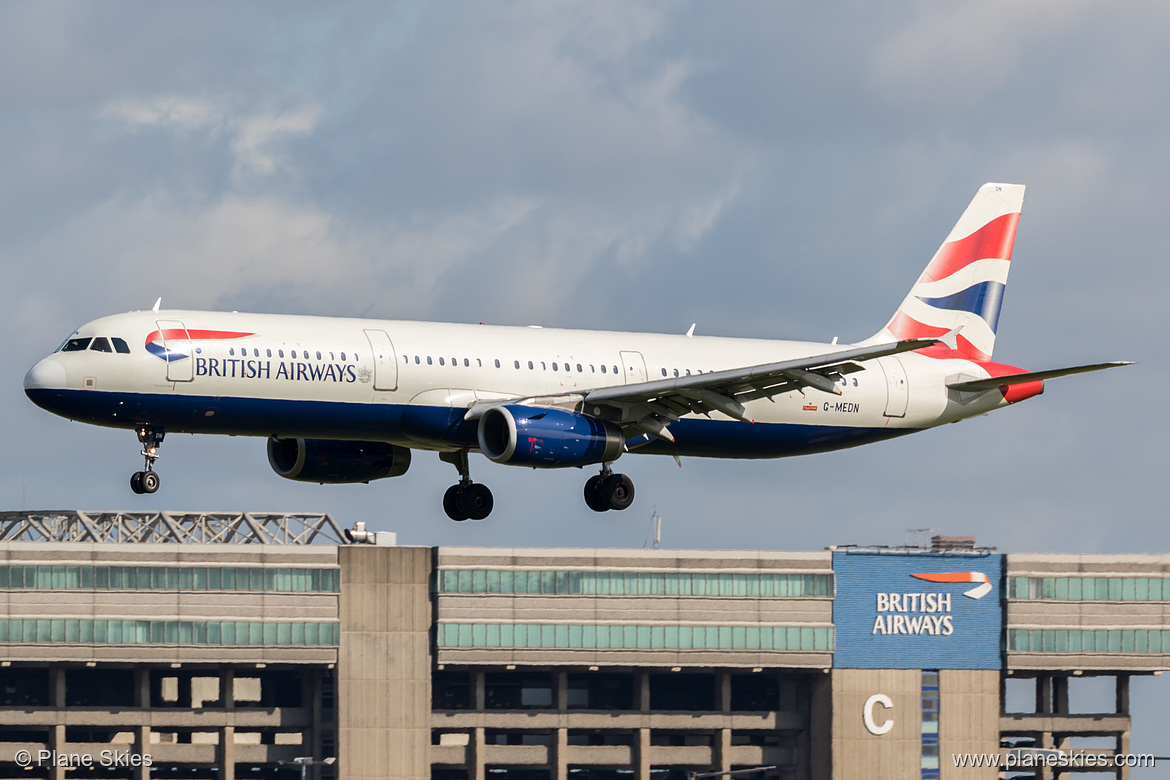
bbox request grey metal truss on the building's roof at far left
[0,510,346,545]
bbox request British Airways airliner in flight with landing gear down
[25,184,1128,520]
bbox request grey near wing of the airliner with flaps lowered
[583,338,940,441]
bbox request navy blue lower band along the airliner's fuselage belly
[26,389,915,458]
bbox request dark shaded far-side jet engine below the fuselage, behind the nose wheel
[268,436,411,484]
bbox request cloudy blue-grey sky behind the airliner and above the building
[0,0,1170,776]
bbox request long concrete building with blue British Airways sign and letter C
[0,512,1170,780]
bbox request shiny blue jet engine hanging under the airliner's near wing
[479,405,625,469]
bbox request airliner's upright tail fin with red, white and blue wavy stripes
[867,184,1024,361]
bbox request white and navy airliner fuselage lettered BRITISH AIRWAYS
[26,311,1020,457]
